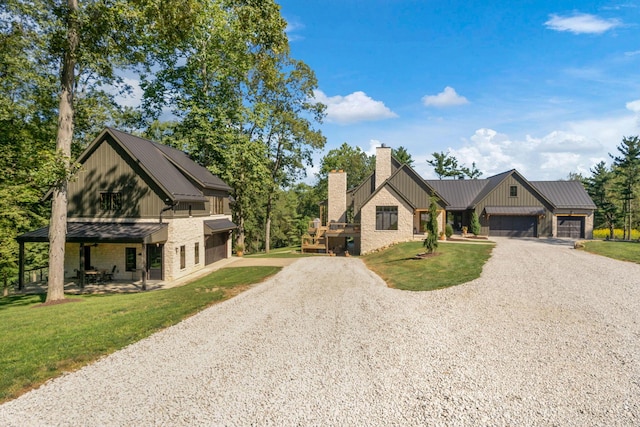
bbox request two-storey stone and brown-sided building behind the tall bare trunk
[17,128,236,286]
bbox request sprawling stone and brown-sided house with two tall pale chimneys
[302,146,595,254]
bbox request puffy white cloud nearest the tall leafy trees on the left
[313,90,398,124]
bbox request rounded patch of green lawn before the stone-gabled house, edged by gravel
[362,242,494,291]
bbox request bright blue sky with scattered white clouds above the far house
[278,0,640,182]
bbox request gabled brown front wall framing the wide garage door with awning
[475,175,553,237]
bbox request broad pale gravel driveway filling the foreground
[0,239,640,426]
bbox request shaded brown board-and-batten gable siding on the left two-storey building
[68,138,171,219]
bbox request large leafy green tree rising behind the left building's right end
[143,0,324,254]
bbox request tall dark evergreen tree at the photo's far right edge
[610,136,640,240]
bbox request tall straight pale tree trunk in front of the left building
[47,0,79,302]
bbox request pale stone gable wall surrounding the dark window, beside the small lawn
[360,188,413,255]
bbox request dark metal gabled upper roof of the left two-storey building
[78,128,230,202]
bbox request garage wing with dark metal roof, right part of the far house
[427,169,596,239]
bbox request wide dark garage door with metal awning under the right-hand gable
[485,206,544,237]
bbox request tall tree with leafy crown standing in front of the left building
[0,0,198,302]
